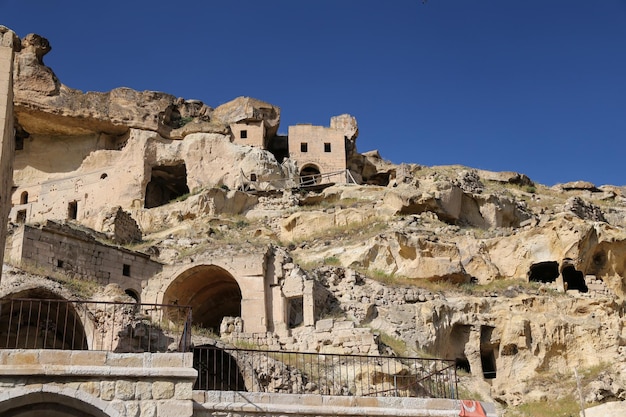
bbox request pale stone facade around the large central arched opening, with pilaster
[142,247,315,337]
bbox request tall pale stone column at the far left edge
[0,26,19,279]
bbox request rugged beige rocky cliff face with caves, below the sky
[4,29,626,412]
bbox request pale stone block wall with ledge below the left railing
[0,350,197,417]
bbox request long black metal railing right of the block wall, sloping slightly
[193,346,458,399]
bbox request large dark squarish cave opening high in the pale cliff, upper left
[144,162,189,208]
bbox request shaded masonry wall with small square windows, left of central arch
[8,222,163,295]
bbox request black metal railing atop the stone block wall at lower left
[0,298,191,353]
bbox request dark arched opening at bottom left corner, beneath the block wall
[0,392,117,417]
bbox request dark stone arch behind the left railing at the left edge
[0,287,93,350]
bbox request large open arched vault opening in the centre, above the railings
[163,265,242,333]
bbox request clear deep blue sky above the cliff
[0,0,626,185]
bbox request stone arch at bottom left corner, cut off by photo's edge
[0,385,121,417]
